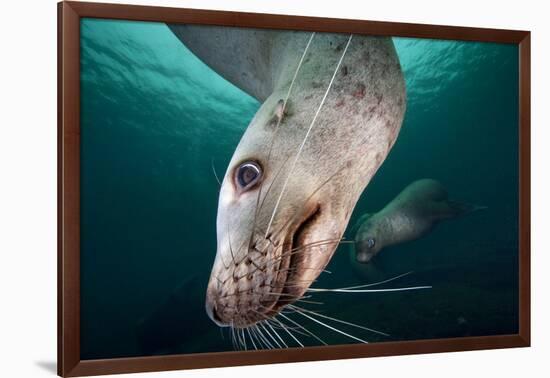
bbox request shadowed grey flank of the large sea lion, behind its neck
[168,24,285,102]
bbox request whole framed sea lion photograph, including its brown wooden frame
[58,2,530,376]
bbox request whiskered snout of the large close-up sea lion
[205,198,337,328]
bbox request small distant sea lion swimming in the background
[353,179,485,263]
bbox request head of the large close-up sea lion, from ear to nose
[206,92,358,327]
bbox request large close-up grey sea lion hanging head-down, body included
[169,25,406,328]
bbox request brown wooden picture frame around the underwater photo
[58,2,531,376]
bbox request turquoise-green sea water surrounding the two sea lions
[81,19,518,359]
